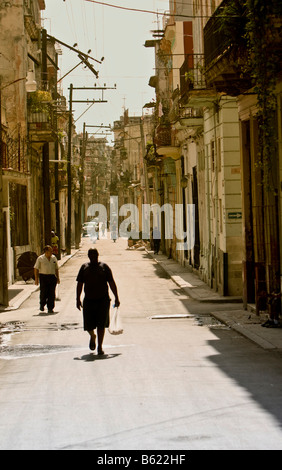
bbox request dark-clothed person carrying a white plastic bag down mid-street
[76,248,120,355]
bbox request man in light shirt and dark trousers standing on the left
[34,245,60,313]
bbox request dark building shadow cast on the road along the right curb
[143,253,282,429]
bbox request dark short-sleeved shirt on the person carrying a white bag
[76,262,113,300]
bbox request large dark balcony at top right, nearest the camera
[204,0,251,96]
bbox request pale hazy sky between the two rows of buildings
[42,0,169,138]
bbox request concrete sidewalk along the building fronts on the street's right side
[146,250,282,350]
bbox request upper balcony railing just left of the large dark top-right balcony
[180,54,206,96]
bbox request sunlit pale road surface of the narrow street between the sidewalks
[0,238,282,450]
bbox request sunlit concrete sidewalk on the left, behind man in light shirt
[0,250,78,313]
